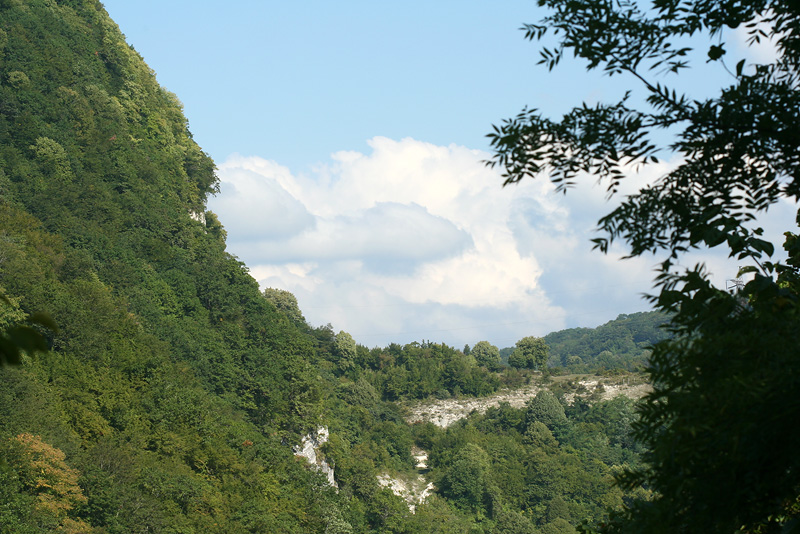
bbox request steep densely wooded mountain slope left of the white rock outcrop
[0,0,338,532]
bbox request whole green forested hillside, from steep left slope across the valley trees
[0,0,638,534]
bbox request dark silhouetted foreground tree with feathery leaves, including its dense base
[489,0,800,532]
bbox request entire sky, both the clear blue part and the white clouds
[103,0,793,348]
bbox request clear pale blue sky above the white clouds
[104,0,613,171]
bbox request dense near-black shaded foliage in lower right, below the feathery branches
[608,259,800,530]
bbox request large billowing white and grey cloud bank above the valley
[209,137,663,347]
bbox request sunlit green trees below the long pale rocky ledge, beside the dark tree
[418,392,637,532]
